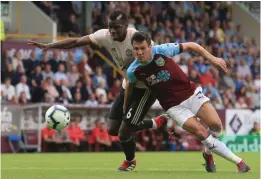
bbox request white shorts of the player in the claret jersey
[166,87,210,127]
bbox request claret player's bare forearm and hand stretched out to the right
[181,42,227,73]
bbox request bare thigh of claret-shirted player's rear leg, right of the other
[196,102,222,131]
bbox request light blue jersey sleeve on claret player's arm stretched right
[152,43,183,57]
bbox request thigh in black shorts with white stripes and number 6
[124,88,156,125]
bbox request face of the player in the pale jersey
[109,21,127,41]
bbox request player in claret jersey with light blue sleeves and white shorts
[125,32,250,173]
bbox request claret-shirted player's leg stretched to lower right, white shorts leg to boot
[167,106,250,172]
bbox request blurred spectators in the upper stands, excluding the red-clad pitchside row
[1,2,260,109]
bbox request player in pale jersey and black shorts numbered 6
[27,10,168,171]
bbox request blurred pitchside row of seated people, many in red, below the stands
[41,117,193,152]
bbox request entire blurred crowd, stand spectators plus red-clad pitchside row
[0,1,260,151]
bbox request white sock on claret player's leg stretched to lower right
[201,135,242,164]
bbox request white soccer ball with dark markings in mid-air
[45,105,71,130]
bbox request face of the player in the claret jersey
[133,40,152,64]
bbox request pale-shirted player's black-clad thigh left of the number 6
[107,88,124,136]
